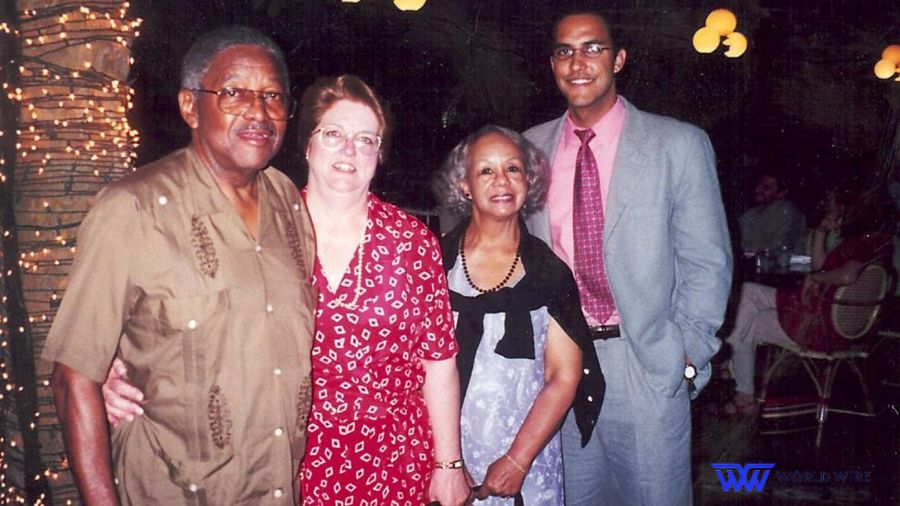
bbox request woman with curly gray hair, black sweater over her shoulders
[434,125,604,506]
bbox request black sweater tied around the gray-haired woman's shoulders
[441,218,606,446]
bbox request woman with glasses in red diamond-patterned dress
[299,76,469,505]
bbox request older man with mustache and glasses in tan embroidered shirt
[43,27,316,505]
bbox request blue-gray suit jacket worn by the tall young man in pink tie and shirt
[525,98,732,396]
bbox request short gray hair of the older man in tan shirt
[181,26,290,91]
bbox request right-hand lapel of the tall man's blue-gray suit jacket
[603,98,648,242]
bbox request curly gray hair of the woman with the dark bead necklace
[431,125,550,216]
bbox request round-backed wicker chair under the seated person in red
[759,264,890,446]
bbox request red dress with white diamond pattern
[300,195,457,506]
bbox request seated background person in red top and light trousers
[725,191,894,414]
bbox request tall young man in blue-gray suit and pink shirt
[525,11,732,506]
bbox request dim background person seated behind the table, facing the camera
[738,171,806,253]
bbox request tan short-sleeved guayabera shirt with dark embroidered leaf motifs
[42,147,316,505]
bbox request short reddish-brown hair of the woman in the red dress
[297,74,393,162]
